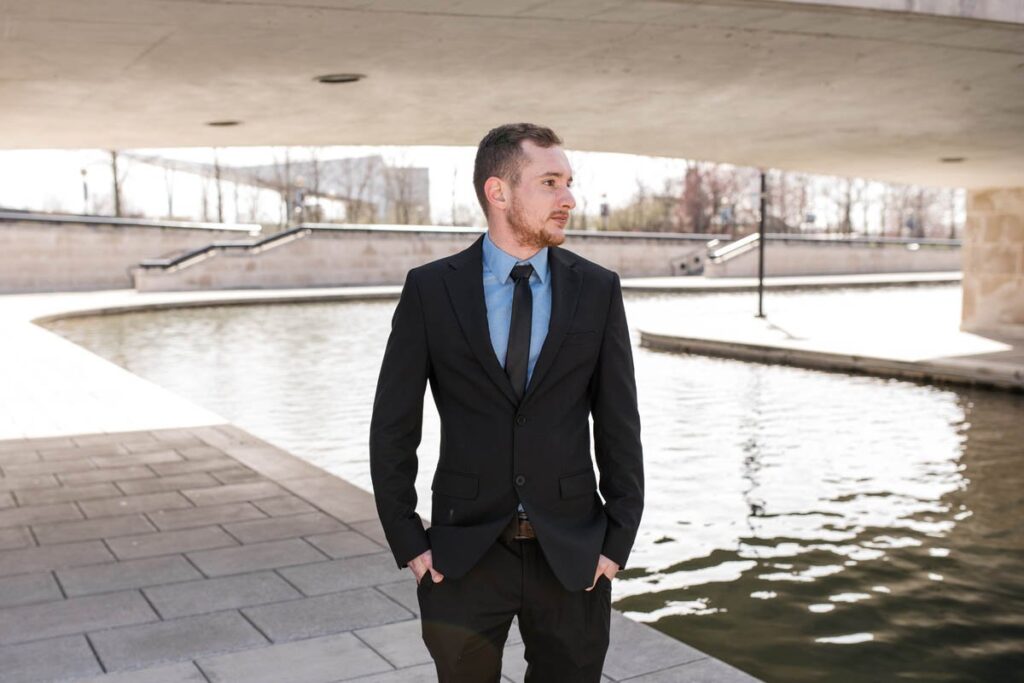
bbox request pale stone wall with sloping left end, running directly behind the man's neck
[134,226,714,291]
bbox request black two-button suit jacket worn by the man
[370,236,644,590]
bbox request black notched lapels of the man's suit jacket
[444,234,583,405]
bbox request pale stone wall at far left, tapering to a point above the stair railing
[0,213,259,293]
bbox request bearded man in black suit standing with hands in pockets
[370,124,644,683]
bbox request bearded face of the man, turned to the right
[505,140,575,249]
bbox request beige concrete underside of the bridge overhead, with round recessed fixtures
[0,0,1024,187]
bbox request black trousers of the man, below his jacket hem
[416,518,611,683]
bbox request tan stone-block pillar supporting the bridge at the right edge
[961,187,1024,339]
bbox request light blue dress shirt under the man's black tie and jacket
[483,232,551,510]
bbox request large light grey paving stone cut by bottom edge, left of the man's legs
[198,633,392,683]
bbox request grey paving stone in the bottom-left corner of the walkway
[0,636,102,683]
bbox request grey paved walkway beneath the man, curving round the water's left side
[0,287,756,683]
